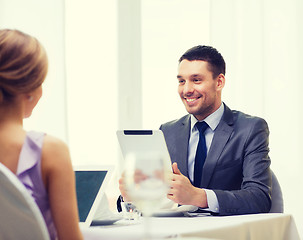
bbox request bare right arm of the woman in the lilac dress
[42,135,83,240]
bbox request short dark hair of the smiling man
[179,45,225,78]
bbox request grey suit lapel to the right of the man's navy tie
[201,105,234,188]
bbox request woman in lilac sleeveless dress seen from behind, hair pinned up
[0,29,82,240]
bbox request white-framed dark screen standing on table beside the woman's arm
[74,166,114,227]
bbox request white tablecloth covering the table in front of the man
[82,213,300,240]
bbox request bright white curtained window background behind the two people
[0,0,303,236]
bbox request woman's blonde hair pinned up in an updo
[0,29,48,104]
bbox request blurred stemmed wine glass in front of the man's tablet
[124,152,170,239]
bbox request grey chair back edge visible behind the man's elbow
[269,171,284,213]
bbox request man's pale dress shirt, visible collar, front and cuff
[188,103,224,213]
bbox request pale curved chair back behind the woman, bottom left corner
[0,163,49,240]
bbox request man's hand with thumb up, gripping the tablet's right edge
[167,163,208,208]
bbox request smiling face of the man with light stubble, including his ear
[177,60,225,120]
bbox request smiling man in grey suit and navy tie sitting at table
[120,46,271,215]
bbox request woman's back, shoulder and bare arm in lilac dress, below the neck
[0,127,82,239]
